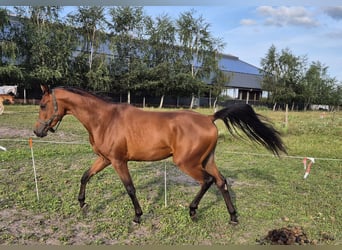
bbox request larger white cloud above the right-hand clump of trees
[257,6,319,27]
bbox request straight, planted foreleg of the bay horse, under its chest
[112,161,143,223]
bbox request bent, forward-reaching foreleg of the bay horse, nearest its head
[78,157,110,209]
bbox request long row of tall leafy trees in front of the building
[0,6,224,99]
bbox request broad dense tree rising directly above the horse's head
[15,6,75,87]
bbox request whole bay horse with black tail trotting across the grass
[34,85,286,224]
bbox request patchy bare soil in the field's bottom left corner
[0,209,118,245]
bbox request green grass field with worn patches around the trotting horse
[0,105,342,245]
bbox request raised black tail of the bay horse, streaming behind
[213,104,286,156]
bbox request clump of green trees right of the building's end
[261,45,341,109]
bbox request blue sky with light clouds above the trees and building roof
[144,4,342,82]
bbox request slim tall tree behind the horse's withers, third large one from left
[108,6,147,103]
